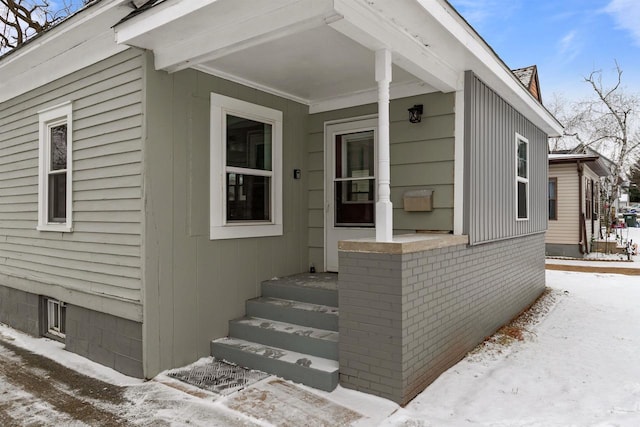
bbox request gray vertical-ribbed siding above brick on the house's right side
[464,71,548,245]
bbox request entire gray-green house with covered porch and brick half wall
[0,0,561,403]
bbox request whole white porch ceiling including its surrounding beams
[115,0,459,112]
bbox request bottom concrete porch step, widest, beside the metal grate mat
[211,338,338,391]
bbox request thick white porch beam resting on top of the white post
[330,0,459,92]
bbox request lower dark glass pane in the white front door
[335,179,375,227]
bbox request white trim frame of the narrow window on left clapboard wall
[36,101,73,233]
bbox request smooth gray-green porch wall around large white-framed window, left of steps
[143,54,309,377]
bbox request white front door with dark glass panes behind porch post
[325,118,378,271]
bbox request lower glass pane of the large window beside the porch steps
[227,173,271,221]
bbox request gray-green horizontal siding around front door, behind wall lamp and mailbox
[308,93,455,267]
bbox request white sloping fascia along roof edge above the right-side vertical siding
[417,0,563,136]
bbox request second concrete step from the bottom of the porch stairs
[229,317,338,360]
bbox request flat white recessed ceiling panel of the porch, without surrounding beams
[196,25,428,106]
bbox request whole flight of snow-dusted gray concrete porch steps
[211,273,339,391]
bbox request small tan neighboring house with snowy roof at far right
[545,153,609,258]
